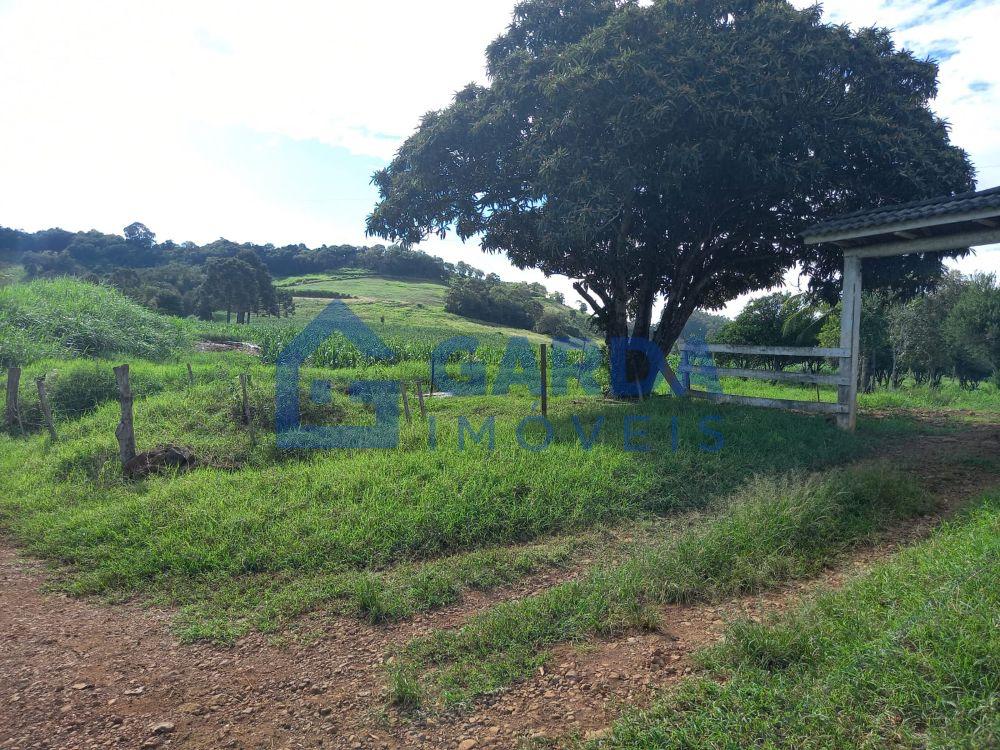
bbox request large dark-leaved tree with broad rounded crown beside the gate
[368,0,973,396]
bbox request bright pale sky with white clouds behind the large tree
[0,0,1000,315]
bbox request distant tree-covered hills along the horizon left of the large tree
[0,222,590,336]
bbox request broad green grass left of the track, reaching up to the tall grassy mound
[0,281,972,664]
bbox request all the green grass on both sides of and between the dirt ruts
[0,276,1000,748]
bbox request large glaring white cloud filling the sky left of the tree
[0,0,512,242]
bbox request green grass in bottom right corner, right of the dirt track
[590,490,1000,750]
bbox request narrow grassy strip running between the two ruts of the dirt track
[390,466,929,706]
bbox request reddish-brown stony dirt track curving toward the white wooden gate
[0,426,1000,750]
